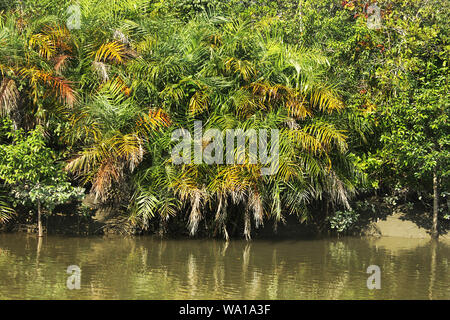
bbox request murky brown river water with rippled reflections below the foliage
[0,234,450,299]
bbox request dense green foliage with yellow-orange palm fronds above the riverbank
[0,0,450,239]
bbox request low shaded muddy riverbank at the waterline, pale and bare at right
[0,211,450,241]
